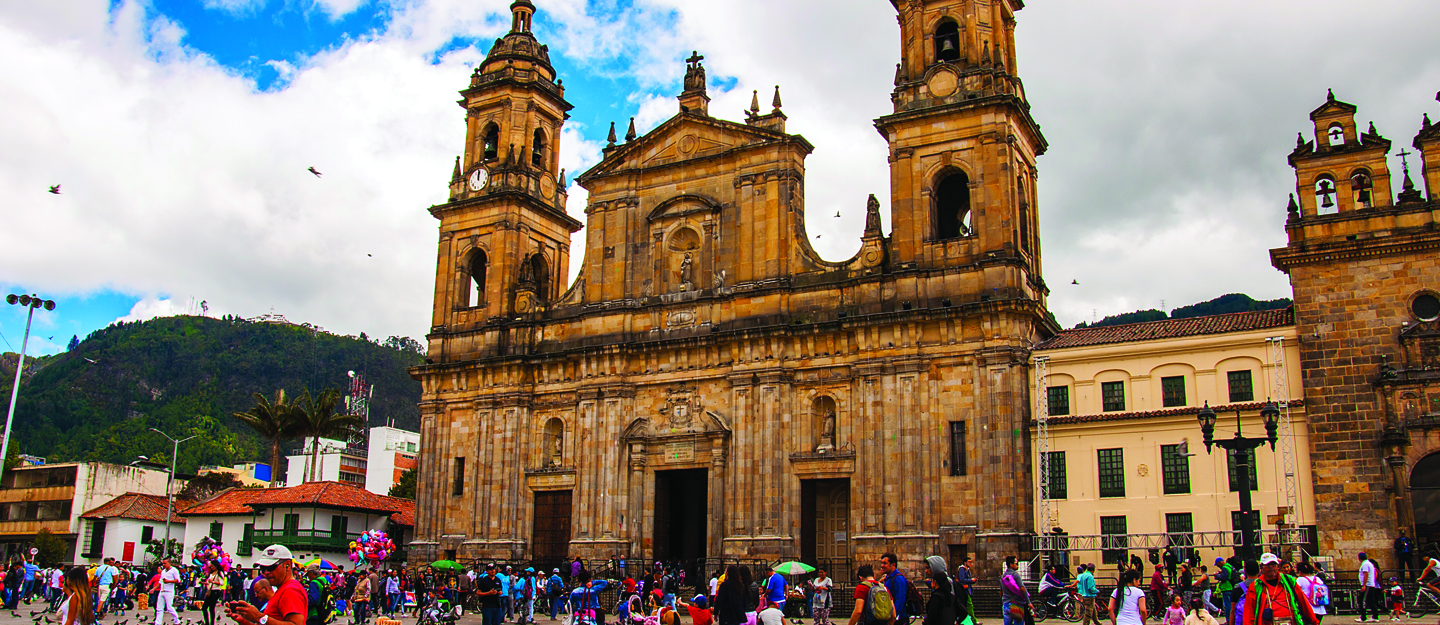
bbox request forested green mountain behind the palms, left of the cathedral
[0,317,425,472]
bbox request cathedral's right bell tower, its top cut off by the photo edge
[876,0,1047,292]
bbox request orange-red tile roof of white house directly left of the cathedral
[184,482,415,526]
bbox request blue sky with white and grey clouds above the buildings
[0,0,1440,353]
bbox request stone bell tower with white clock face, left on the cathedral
[431,0,582,354]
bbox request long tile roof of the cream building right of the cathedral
[1035,307,1295,351]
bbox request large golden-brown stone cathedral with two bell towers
[410,0,1058,569]
